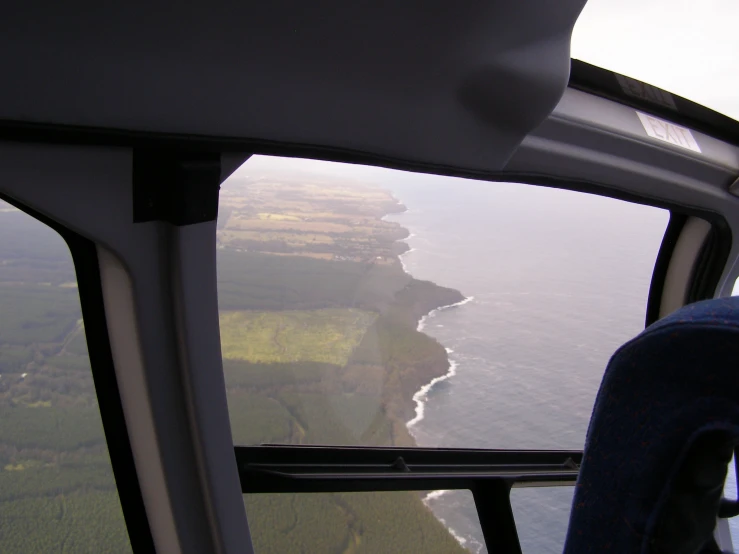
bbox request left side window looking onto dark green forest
[0,202,131,554]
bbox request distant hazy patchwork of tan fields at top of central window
[218,178,407,264]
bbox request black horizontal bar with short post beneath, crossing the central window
[235,445,582,554]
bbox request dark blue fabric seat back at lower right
[565,297,739,554]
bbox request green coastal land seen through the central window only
[218,170,464,553]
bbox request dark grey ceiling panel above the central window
[0,0,584,170]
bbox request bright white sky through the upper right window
[571,0,739,119]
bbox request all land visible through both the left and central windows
[0,169,465,554]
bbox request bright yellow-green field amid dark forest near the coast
[220,308,376,366]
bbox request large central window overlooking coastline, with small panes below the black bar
[217,157,668,552]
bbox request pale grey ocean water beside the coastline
[385,178,736,554]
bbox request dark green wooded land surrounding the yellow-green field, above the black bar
[219,251,463,445]
